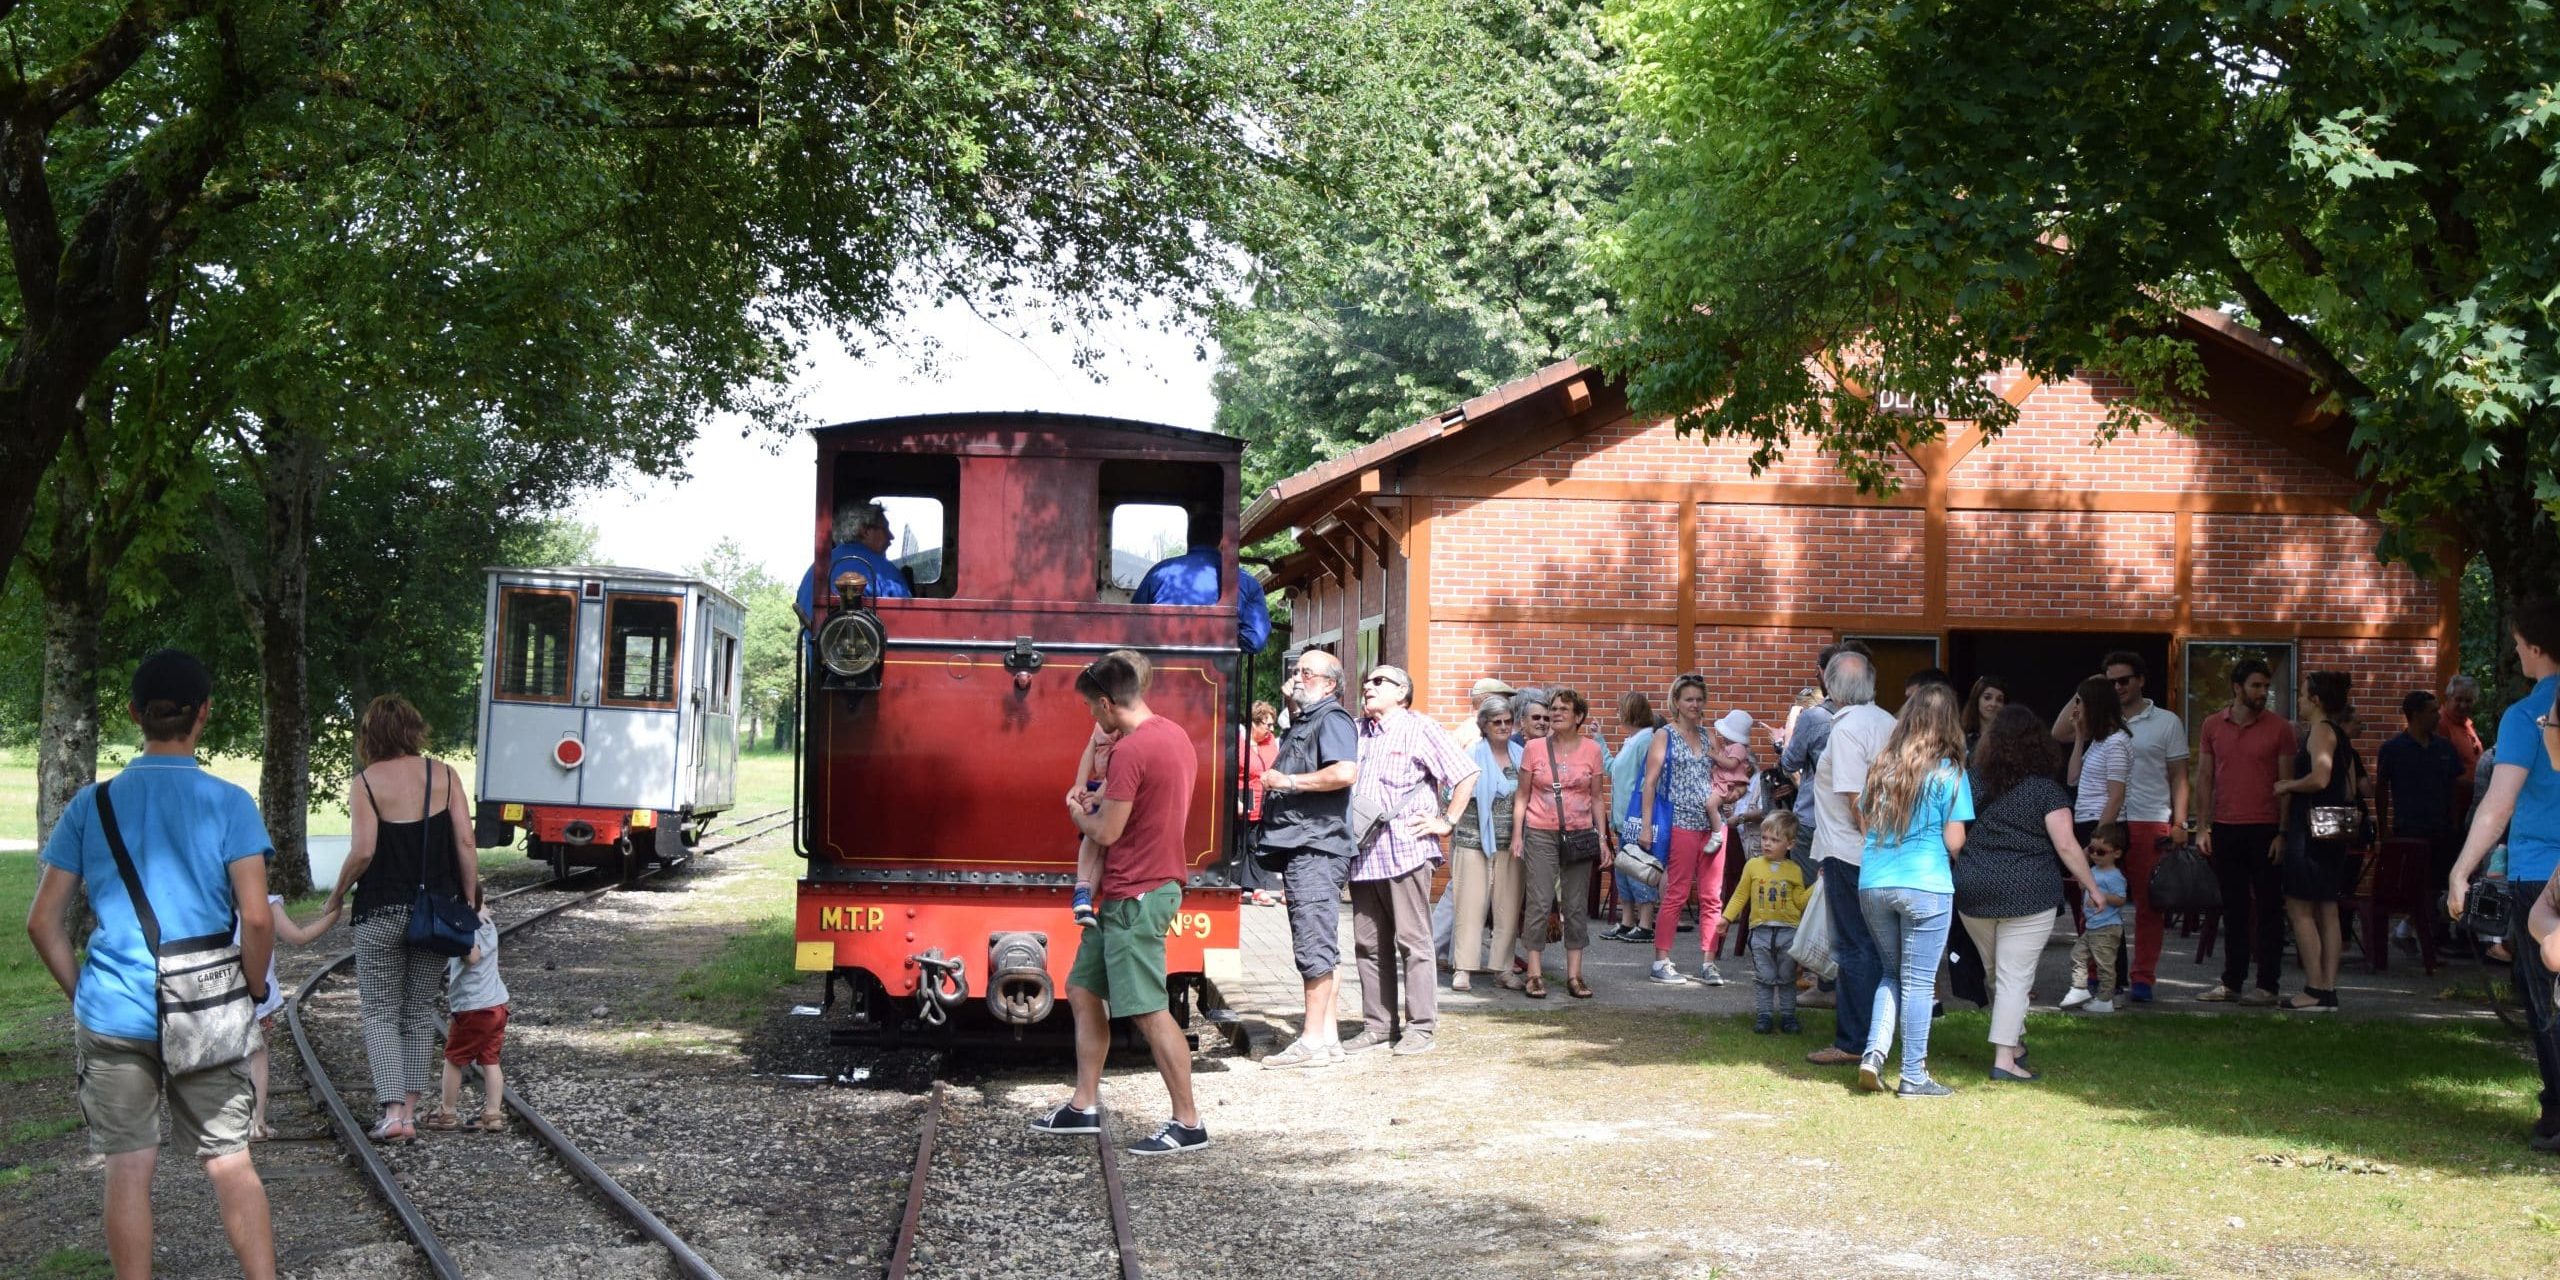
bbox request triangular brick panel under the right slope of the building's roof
[1948,376,2355,497]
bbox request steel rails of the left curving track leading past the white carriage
[284,809,791,1280]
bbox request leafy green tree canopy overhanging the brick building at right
[1597,0,2560,614]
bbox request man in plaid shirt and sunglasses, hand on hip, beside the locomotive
[1341,666,1477,1055]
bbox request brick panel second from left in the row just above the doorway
[1674,502,1925,614]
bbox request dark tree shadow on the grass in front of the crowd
[1477,1009,2560,1172]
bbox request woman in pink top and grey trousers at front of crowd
[1510,689,1618,1001]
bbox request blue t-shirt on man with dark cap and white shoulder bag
[44,755,269,1039]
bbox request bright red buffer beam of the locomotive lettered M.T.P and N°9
[791,881,1244,1034]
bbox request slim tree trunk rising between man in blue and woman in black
[259,420,320,899]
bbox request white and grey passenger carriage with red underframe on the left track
[474,566,745,868]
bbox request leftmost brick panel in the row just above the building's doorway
[1431,499,1679,611]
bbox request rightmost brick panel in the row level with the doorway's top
[2194,512,2437,625]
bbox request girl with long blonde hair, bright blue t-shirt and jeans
[1859,684,1974,1098]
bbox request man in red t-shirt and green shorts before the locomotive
[1032,653,1208,1155]
